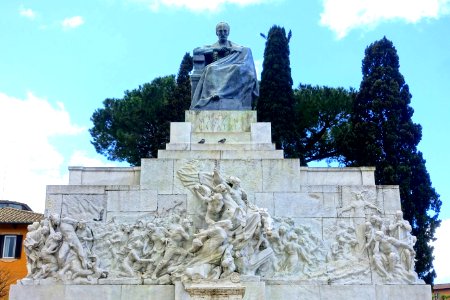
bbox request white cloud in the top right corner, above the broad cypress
[320,0,450,38]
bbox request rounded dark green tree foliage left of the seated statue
[89,76,176,166]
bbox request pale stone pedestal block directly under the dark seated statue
[185,110,256,132]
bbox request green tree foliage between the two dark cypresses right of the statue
[292,85,356,165]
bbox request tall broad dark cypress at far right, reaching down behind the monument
[339,37,441,283]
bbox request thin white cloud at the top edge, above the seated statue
[128,0,279,12]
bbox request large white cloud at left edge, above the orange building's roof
[0,93,85,212]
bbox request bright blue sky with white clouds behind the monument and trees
[0,0,450,283]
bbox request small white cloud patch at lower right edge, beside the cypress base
[433,219,450,283]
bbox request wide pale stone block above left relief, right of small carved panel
[107,189,158,212]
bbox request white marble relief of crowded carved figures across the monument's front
[24,168,418,284]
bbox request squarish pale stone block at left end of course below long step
[140,158,174,194]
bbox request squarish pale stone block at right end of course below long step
[262,159,300,192]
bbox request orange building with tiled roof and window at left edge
[0,200,44,299]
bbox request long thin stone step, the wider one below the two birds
[158,150,284,159]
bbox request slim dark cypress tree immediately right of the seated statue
[256,26,295,156]
